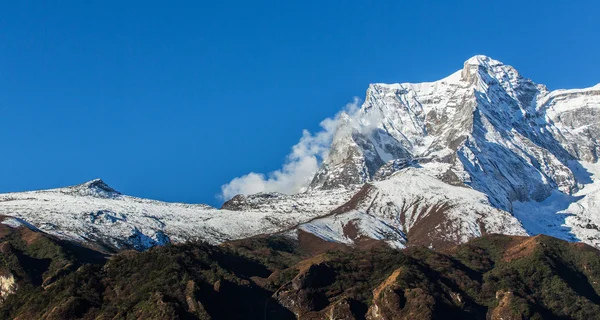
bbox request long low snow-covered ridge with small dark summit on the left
[0,180,352,250]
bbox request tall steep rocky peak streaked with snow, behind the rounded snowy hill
[310,56,600,210]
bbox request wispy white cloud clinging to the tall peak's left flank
[220,97,360,200]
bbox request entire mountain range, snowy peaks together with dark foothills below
[0,56,600,320]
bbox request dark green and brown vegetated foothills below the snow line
[0,221,600,319]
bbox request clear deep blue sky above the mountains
[0,1,600,205]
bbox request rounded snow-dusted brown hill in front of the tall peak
[299,167,527,248]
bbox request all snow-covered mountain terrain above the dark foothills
[0,56,600,249]
